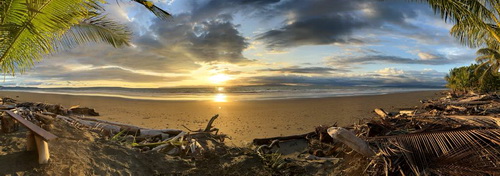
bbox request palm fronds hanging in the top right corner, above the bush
[419,0,500,81]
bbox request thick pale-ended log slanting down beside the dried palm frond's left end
[327,127,375,157]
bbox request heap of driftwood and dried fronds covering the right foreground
[253,93,500,175]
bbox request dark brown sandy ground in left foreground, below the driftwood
[0,117,338,175]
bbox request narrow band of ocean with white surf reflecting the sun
[0,86,444,102]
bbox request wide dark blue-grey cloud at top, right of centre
[257,0,428,49]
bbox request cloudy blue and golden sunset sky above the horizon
[1,0,477,88]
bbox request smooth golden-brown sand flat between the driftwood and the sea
[0,91,439,146]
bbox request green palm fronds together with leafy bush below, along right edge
[420,0,500,92]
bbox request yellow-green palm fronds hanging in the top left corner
[0,0,170,75]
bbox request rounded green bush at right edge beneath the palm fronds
[445,64,500,93]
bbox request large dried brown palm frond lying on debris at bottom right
[370,129,500,175]
